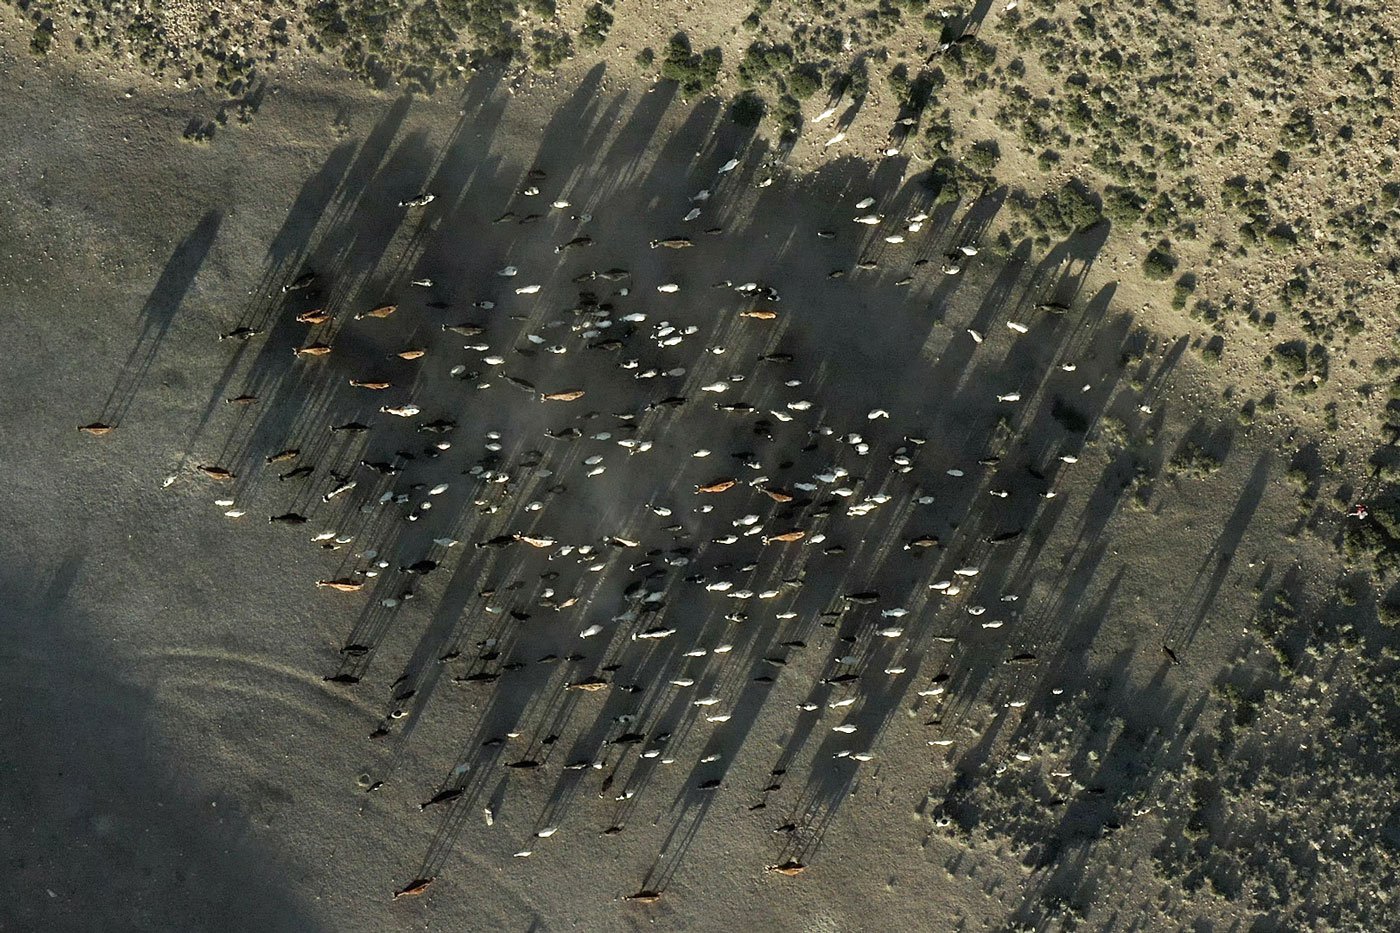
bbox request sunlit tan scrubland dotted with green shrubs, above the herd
[15,0,1400,424]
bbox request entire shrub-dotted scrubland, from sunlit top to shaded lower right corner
[2,0,1400,930]
